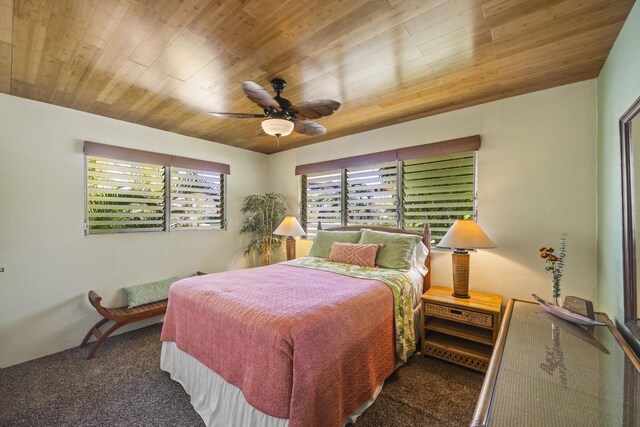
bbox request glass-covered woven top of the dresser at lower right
[487,301,640,426]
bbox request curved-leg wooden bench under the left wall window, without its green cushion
[80,291,169,359]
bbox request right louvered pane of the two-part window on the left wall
[171,167,225,230]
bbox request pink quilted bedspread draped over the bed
[161,265,395,427]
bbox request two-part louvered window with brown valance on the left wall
[85,142,230,234]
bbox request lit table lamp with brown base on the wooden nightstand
[438,219,496,298]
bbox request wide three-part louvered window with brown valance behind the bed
[296,136,480,244]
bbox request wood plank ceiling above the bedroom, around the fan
[0,0,633,153]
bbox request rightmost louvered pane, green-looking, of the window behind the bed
[402,152,475,244]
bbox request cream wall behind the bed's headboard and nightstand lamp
[269,80,596,306]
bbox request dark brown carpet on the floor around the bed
[0,324,483,427]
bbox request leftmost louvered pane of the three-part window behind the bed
[303,171,342,238]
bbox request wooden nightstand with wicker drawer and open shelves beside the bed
[420,286,502,372]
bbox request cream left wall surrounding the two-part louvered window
[0,94,267,367]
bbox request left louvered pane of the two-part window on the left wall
[87,156,165,234]
